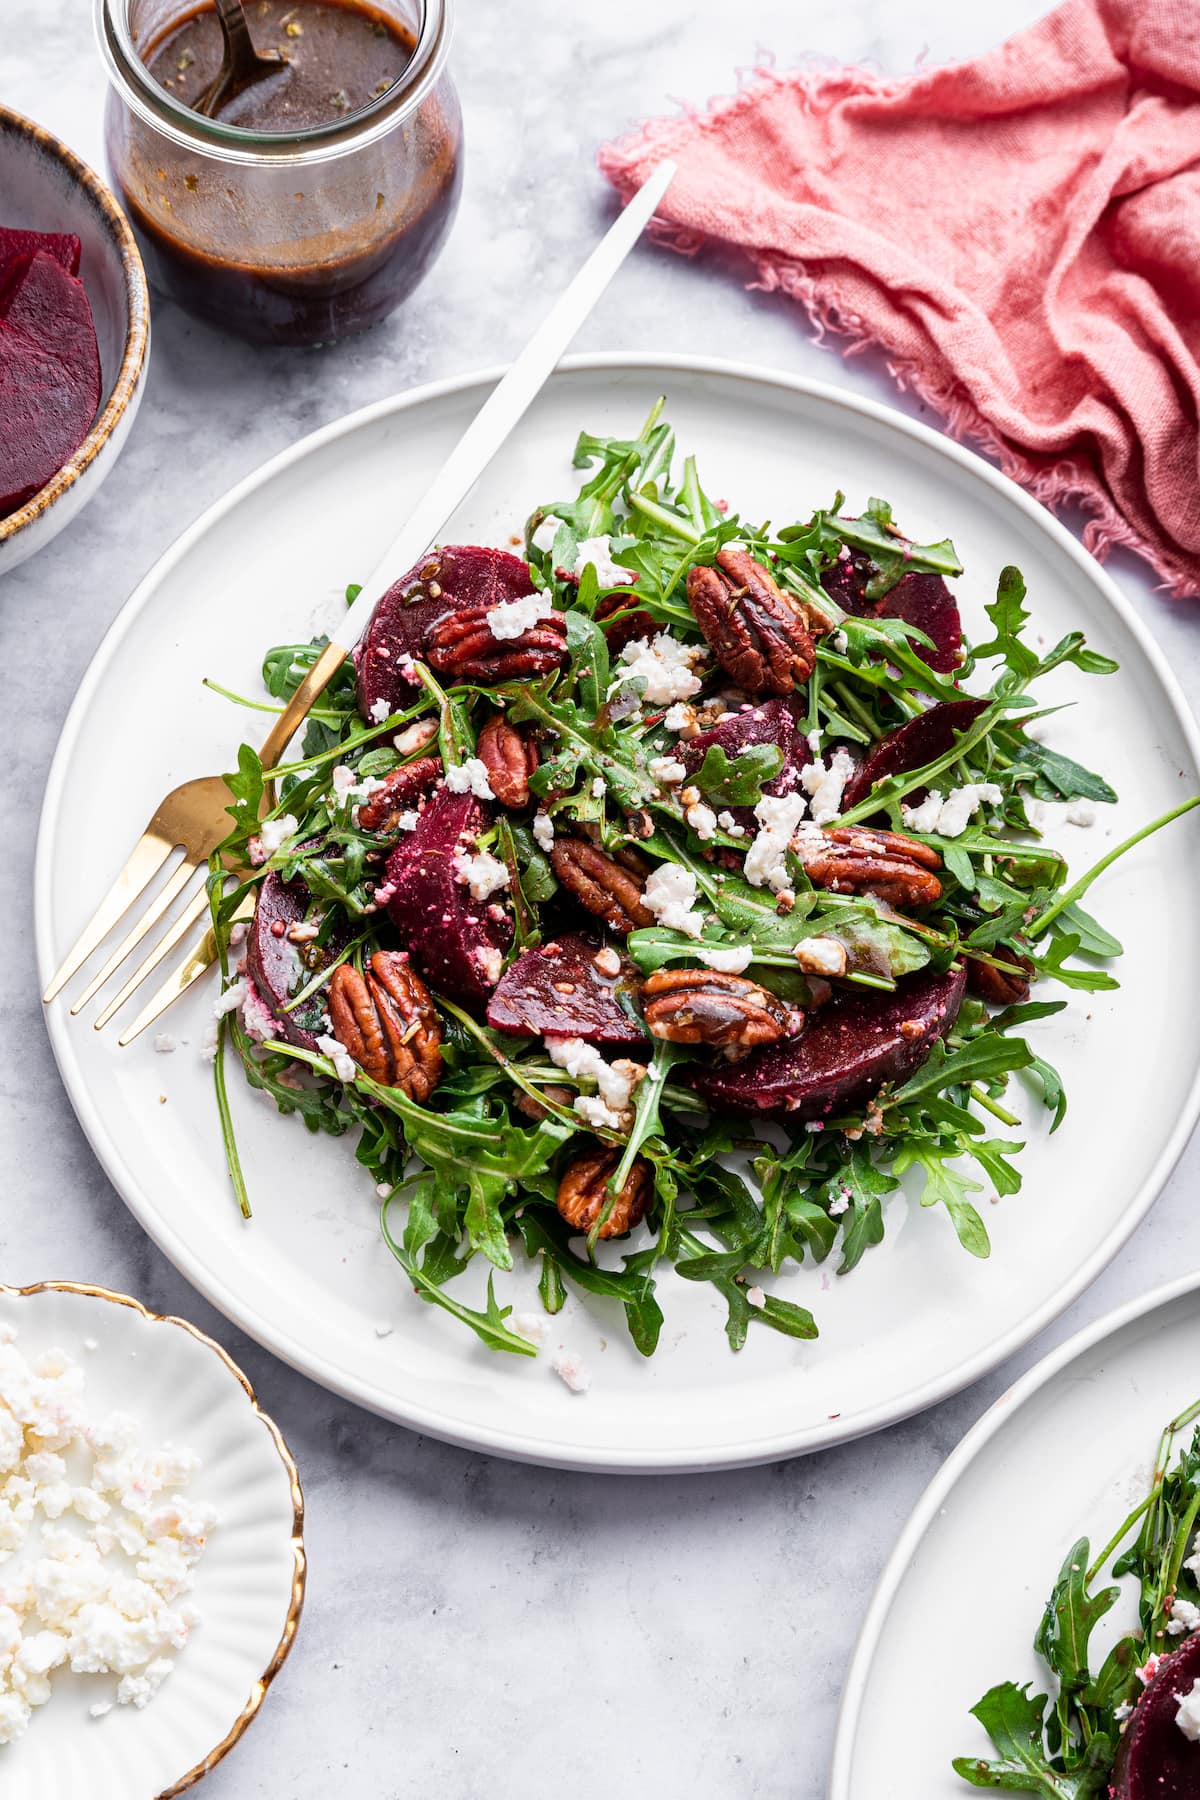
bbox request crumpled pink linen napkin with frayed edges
[599,0,1200,594]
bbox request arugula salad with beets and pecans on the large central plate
[209,403,1195,1355]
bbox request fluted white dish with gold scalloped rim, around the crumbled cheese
[0,1282,304,1800]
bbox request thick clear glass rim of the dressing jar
[95,0,452,166]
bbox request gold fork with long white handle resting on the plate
[43,162,675,1046]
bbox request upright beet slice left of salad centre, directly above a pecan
[387,788,513,1001]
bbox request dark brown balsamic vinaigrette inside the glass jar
[121,0,459,344]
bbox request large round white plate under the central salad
[36,356,1200,1471]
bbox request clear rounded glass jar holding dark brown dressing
[95,0,462,344]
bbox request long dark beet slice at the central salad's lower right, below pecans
[694,963,966,1120]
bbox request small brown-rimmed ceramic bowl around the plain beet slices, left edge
[0,106,149,576]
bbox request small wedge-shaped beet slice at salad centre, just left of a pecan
[488,932,646,1046]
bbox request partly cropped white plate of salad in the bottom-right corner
[829,1274,1200,1800]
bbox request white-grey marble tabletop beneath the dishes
[0,0,1200,1800]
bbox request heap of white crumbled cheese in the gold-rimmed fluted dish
[0,1334,216,1744]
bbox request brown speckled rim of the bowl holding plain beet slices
[0,104,149,549]
